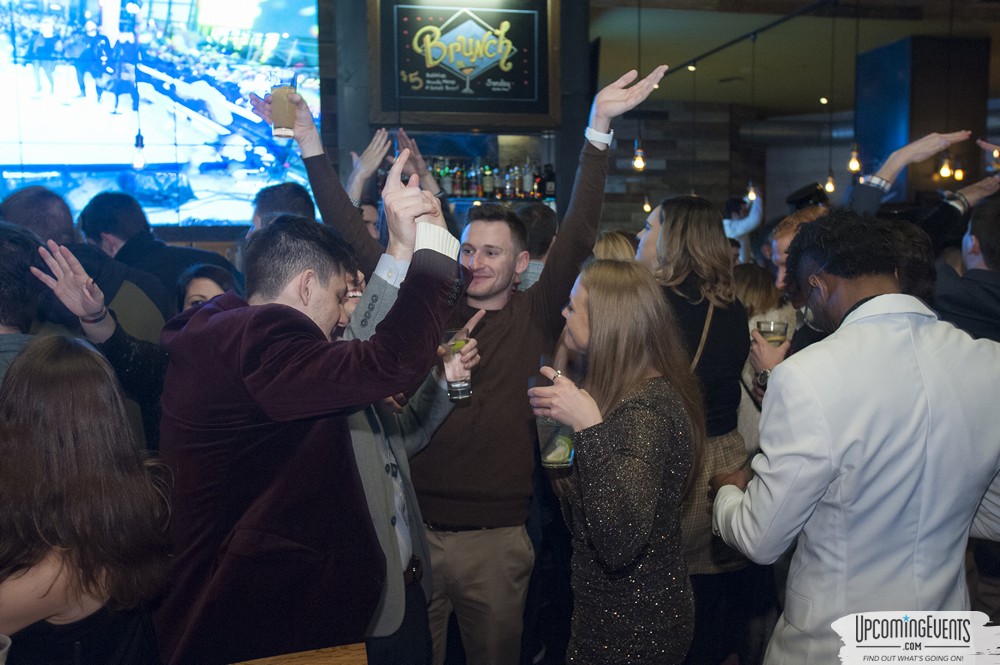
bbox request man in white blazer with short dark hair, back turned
[712,211,1000,665]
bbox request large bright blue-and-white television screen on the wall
[0,0,319,224]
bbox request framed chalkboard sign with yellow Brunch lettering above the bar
[369,0,559,128]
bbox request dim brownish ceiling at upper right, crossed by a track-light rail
[588,0,1000,117]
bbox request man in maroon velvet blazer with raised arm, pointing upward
[156,162,462,665]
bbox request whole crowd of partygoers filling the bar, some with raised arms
[0,55,1000,665]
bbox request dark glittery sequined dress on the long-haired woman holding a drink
[564,378,694,665]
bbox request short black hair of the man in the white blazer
[785,208,896,296]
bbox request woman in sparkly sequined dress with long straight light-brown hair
[528,260,704,665]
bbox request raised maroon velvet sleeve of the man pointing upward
[240,250,464,421]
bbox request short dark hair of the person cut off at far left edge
[0,222,48,333]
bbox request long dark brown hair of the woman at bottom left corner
[0,335,168,609]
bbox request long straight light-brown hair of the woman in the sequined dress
[580,260,705,490]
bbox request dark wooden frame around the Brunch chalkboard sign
[368,0,561,131]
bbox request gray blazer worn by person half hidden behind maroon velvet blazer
[344,275,453,637]
